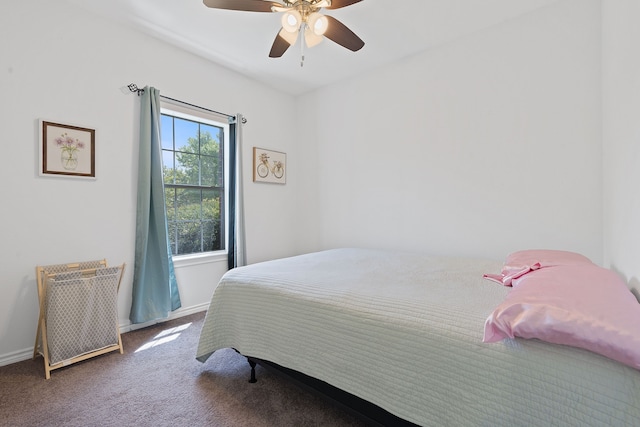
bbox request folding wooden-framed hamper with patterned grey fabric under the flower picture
[33,259,125,379]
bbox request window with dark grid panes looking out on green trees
[161,105,229,256]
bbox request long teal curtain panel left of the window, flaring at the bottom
[129,86,181,323]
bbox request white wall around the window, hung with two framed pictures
[0,0,296,364]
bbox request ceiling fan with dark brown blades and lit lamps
[203,0,364,66]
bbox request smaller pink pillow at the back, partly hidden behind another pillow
[484,249,593,286]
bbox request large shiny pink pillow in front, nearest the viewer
[483,264,640,369]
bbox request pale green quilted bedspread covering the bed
[196,248,640,426]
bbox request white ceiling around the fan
[62,0,558,95]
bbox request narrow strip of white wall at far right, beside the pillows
[602,0,640,294]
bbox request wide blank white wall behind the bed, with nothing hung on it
[297,0,603,263]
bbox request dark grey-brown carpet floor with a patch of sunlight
[0,313,364,427]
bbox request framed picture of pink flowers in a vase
[40,120,96,179]
